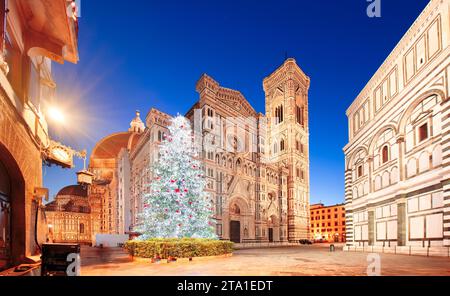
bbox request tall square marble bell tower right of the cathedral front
[263,58,310,241]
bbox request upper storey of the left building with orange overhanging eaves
[0,0,78,150]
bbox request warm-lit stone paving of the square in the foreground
[81,245,450,276]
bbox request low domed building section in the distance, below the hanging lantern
[45,185,93,245]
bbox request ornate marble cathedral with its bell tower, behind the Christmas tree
[91,59,310,242]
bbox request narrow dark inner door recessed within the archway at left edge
[0,160,11,271]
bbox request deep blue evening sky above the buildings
[43,0,428,204]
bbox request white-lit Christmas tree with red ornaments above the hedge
[138,116,216,240]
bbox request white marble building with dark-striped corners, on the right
[344,0,450,249]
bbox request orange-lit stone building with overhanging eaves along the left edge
[0,0,78,271]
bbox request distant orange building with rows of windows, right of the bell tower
[311,203,346,243]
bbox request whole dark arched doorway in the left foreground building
[0,143,26,270]
